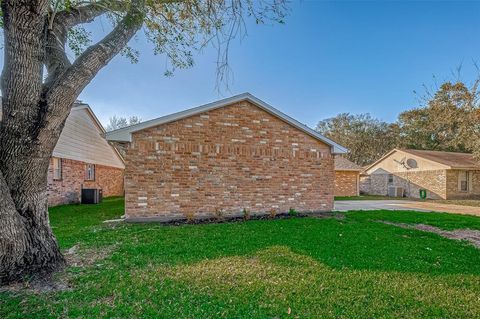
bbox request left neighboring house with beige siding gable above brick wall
[0,103,125,206]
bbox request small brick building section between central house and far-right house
[334,156,363,196]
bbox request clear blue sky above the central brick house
[74,0,480,126]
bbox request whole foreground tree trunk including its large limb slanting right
[0,0,143,285]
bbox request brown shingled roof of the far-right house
[364,148,480,171]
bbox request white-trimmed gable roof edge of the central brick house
[106,93,348,154]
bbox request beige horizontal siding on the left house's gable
[53,107,125,168]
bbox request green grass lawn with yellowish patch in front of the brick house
[0,198,480,318]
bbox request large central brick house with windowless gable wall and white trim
[106,93,346,221]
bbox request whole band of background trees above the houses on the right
[317,80,480,166]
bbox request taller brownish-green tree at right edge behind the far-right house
[398,80,480,154]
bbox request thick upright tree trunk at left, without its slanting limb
[0,1,65,284]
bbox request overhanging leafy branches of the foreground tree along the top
[39,0,288,80]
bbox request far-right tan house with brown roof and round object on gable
[360,149,480,199]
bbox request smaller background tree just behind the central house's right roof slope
[316,113,399,166]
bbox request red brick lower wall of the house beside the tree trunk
[48,159,123,206]
